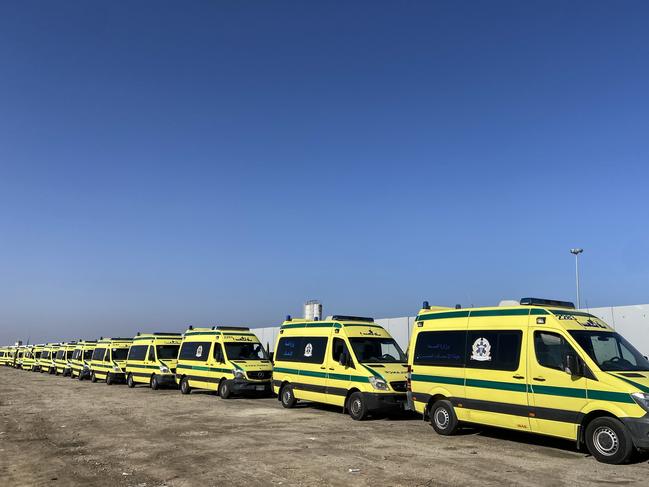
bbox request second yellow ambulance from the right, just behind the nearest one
[273,315,407,420]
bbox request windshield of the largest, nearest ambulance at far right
[570,330,649,372]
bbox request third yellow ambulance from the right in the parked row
[176,326,272,399]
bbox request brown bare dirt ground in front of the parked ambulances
[0,367,649,487]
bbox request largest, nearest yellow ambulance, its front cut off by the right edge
[408,298,649,464]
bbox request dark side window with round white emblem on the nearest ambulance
[466,330,523,371]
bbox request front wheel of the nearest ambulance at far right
[586,417,635,465]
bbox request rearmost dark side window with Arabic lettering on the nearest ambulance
[413,331,466,367]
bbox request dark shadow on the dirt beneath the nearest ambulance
[448,424,649,465]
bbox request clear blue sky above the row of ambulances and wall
[0,1,649,343]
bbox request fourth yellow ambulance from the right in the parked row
[125,332,182,390]
